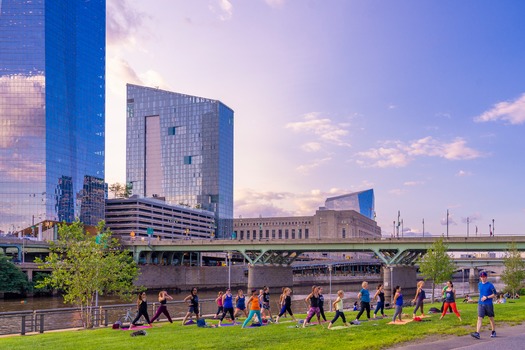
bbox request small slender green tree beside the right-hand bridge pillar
[418,238,456,302]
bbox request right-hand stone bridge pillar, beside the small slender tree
[383,265,417,303]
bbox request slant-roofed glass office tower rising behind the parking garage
[126,84,233,238]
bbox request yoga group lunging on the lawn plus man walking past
[131,271,497,339]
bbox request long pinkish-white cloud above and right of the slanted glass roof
[356,136,482,168]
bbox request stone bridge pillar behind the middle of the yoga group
[247,265,293,295]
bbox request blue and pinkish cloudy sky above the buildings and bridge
[106,0,525,236]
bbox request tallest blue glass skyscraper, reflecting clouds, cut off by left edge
[0,0,106,232]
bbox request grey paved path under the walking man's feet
[391,324,525,350]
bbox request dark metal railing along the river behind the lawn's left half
[0,299,217,335]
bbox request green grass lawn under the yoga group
[0,300,525,350]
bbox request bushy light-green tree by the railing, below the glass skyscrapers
[36,220,138,328]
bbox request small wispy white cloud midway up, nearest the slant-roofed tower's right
[285,112,350,147]
